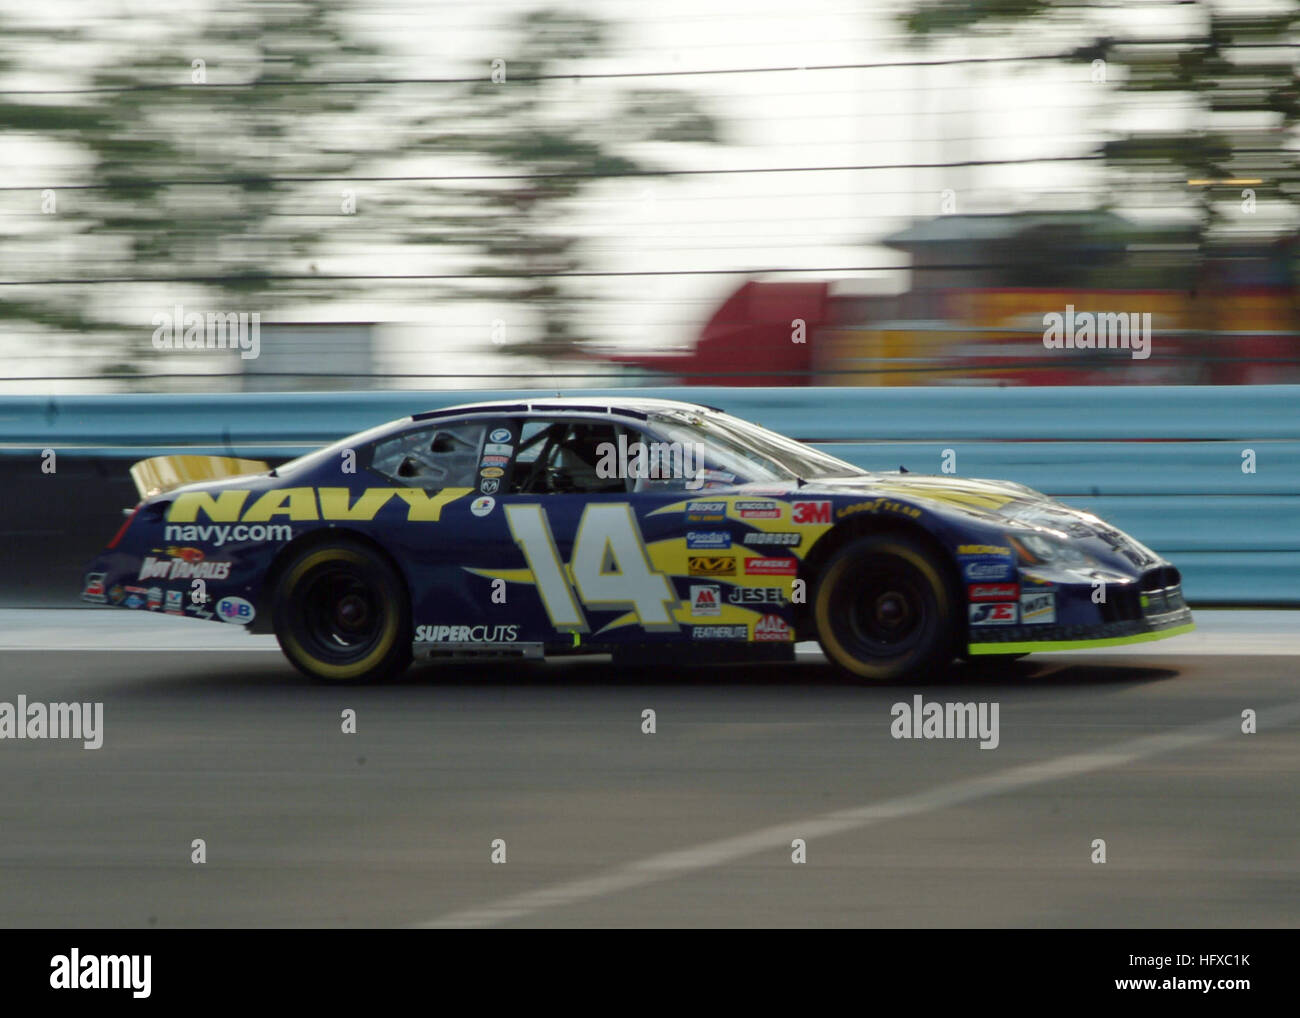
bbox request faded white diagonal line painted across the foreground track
[419,701,1300,928]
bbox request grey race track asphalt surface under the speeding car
[0,611,1300,927]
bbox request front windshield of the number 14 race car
[651,411,867,481]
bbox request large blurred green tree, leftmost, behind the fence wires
[78,0,387,302]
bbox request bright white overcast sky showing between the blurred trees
[0,0,1268,390]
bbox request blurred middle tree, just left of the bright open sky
[403,9,719,355]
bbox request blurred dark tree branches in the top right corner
[900,0,1300,242]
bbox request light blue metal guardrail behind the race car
[0,386,1300,605]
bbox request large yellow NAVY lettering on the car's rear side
[166,488,473,523]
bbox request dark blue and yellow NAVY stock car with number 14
[82,398,1193,681]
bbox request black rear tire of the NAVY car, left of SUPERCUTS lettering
[272,540,412,684]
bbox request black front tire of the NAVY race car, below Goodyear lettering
[813,533,963,683]
